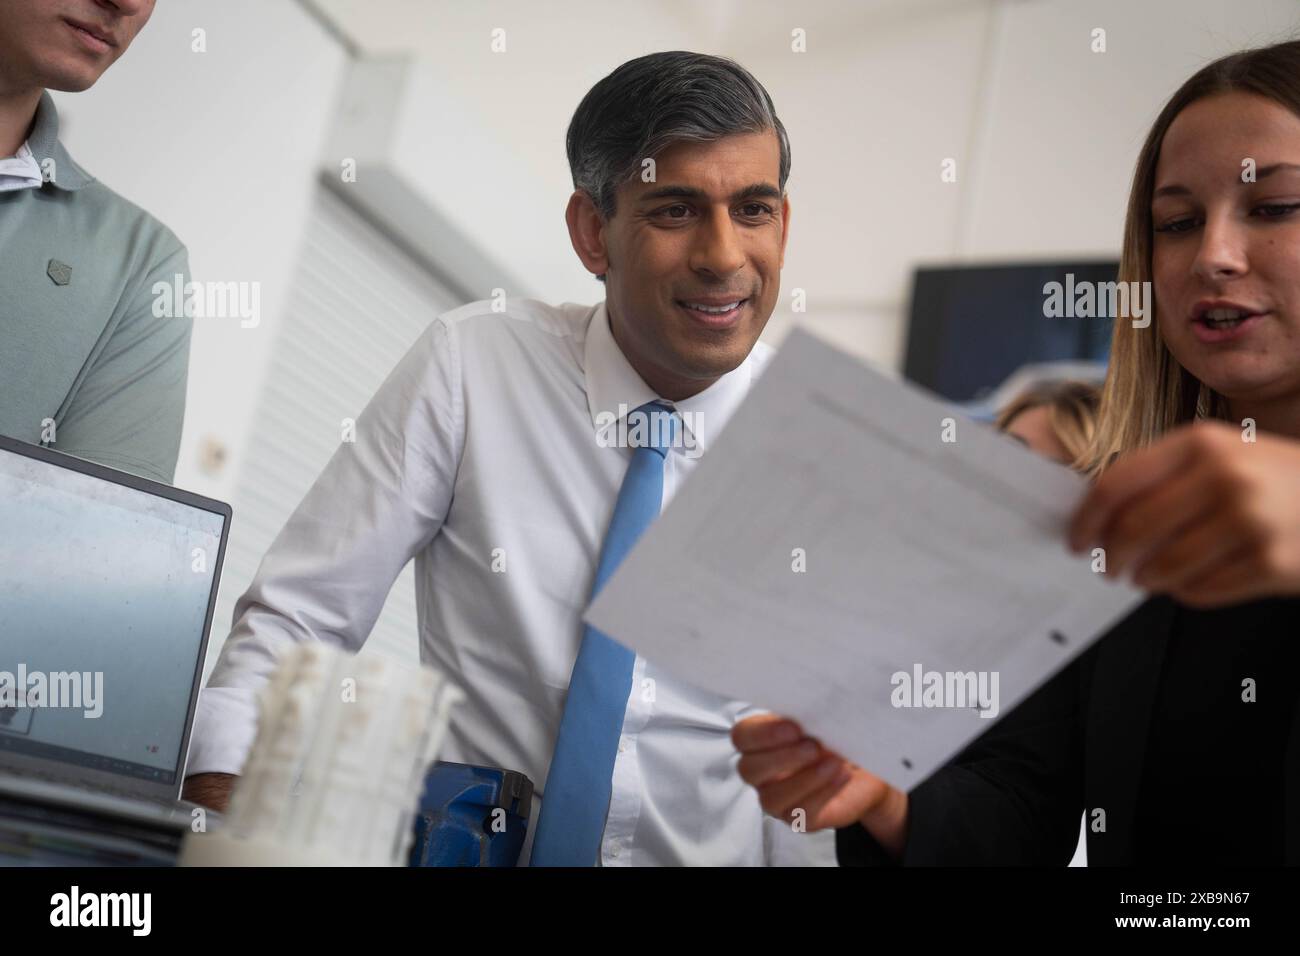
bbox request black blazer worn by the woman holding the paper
[836,597,1300,866]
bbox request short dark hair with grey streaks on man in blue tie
[566,51,790,219]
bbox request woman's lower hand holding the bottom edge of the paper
[732,714,907,856]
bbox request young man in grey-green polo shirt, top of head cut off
[0,0,191,483]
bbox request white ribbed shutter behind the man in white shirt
[204,187,464,676]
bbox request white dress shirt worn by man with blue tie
[186,300,835,866]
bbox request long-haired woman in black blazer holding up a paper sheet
[732,42,1300,865]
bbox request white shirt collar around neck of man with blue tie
[584,302,754,451]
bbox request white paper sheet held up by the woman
[586,330,1143,790]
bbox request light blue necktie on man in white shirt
[530,402,677,866]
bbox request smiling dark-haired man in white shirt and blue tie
[186,52,835,866]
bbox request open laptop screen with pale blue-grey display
[0,436,230,830]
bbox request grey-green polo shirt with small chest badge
[0,92,192,483]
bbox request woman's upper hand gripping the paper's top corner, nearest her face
[1070,421,1300,607]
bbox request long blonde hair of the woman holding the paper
[1086,40,1300,475]
